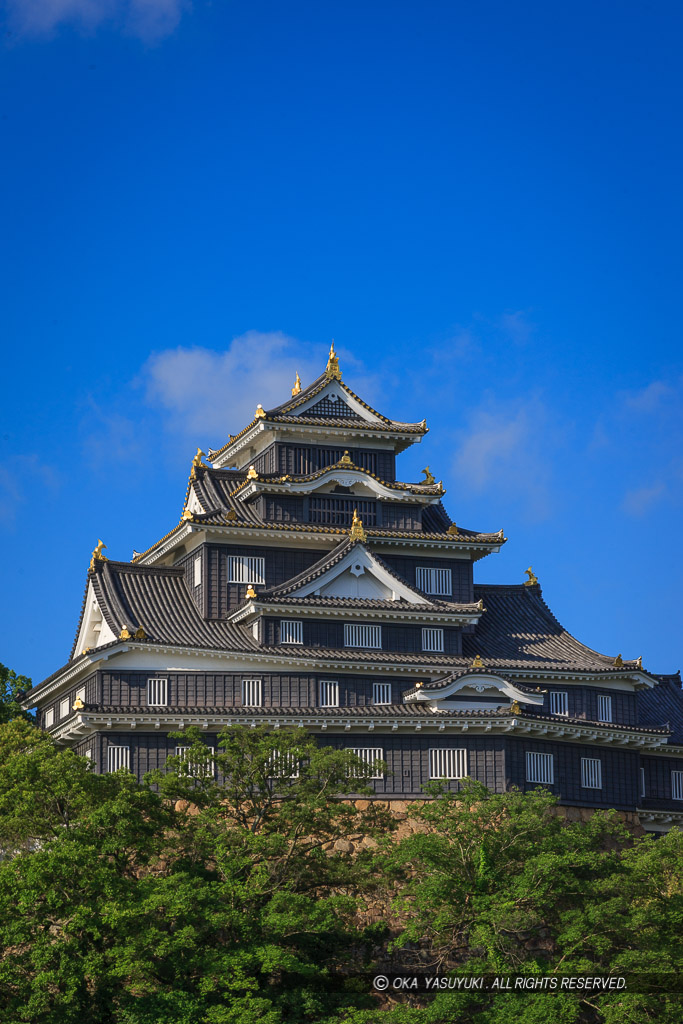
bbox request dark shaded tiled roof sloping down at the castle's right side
[463,584,639,672]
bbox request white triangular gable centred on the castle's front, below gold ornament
[292,545,425,604]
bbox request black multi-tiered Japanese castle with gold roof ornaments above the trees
[25,346,683,830]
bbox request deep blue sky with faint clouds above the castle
[0,0,683,681]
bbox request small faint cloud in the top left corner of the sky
[5,0,187,42]
